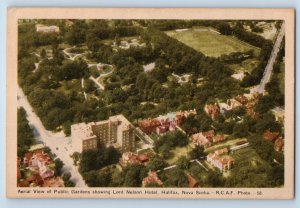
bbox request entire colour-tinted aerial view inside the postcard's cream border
[14,19,287,190]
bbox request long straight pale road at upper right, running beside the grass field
[251,22,285,93]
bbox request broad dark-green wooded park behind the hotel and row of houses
[18,21,248,134]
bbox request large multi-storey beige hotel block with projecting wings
[71,115,136,153]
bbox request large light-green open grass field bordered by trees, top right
[166,30,259,57]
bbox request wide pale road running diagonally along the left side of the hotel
[18,87,86,187]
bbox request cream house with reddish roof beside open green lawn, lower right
[206,148,235,172]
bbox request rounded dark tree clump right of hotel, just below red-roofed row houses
[153,130,189,158]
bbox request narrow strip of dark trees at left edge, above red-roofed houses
[17,108,34,157]
